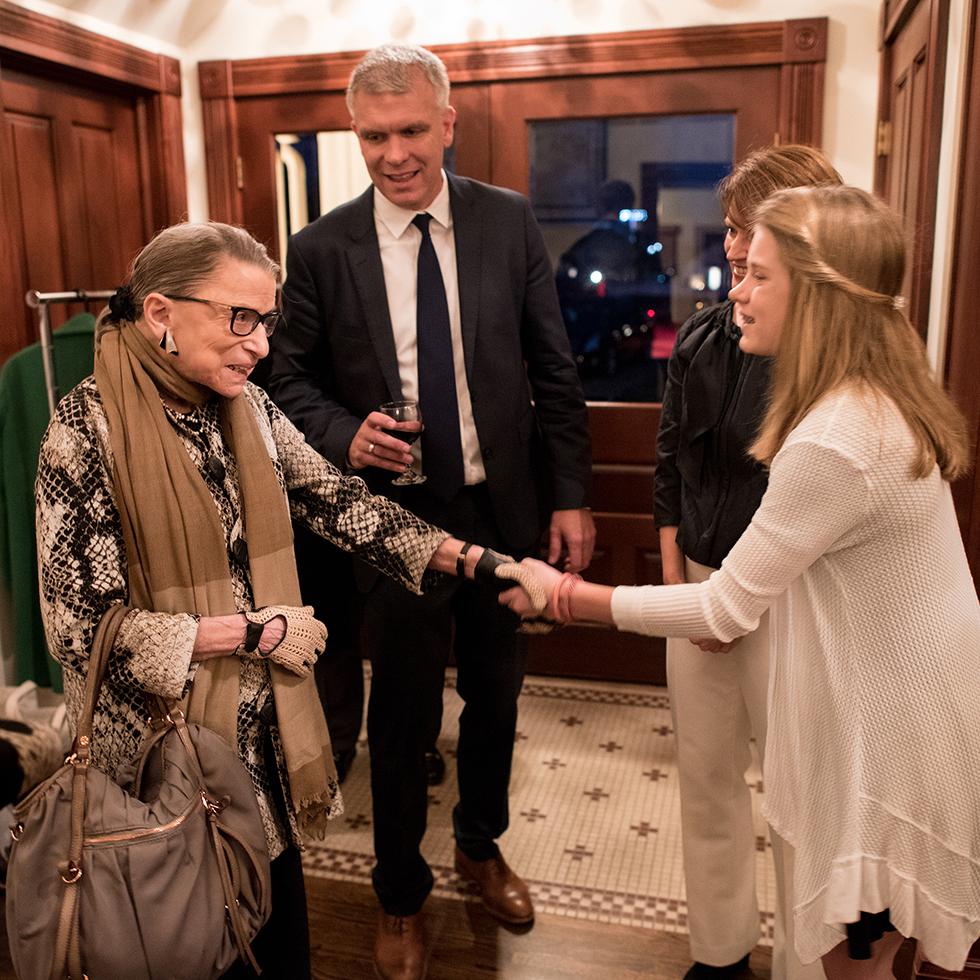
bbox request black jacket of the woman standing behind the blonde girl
[653,300,771,568]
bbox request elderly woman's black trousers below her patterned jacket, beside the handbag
[221,847,310,980]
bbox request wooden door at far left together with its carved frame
[0,0,187,363]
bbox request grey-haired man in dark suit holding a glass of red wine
[270,45,595,978]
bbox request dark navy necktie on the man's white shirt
[412,214,463,500]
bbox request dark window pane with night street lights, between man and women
[529,115,734,401]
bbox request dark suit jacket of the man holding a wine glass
[269,175,591,551]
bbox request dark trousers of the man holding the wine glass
[364,486,526,915]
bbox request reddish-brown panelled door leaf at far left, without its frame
[0,71,152,359]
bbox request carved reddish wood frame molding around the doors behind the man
[198,17,828,223]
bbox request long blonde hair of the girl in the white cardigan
[750,186,969,480]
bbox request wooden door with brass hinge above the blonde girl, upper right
[875,0,949,337]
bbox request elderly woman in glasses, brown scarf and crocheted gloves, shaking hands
[37,223,536,978]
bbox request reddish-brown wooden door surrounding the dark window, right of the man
[490,66,780,683]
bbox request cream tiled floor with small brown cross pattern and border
[306,674,775,943]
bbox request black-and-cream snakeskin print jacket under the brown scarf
[36,378,446,857]
